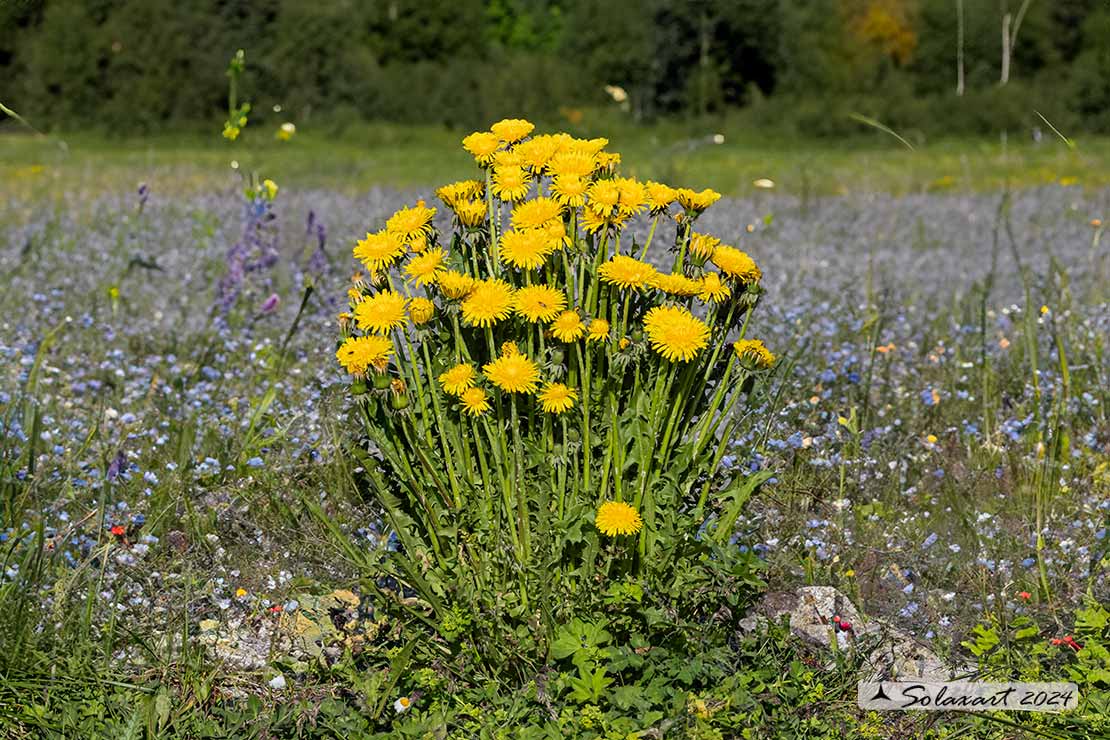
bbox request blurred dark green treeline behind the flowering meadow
[0,0,1110,135]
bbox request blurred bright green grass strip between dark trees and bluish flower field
[8,118,1110,197]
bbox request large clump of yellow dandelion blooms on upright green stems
[336,119,775,590]
